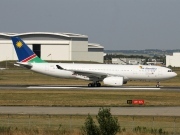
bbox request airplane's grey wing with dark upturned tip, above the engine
[56,65,125,79]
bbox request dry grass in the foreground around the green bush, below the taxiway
[0,114,180,135]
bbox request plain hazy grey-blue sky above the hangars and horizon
[0,0,180,50]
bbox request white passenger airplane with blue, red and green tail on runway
[11,36,177,87]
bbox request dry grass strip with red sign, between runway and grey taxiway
[0,90,180,107]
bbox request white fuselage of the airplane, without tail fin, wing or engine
[28,63,177,81]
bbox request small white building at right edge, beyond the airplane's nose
[166,52,180,67]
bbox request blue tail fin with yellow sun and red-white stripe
[11,37,45,63]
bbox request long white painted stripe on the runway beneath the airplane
[27,86,161,90]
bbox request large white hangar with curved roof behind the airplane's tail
[0,32,104,63]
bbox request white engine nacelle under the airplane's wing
[103,77,123,86]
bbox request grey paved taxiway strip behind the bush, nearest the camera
[0,106,180,116]
